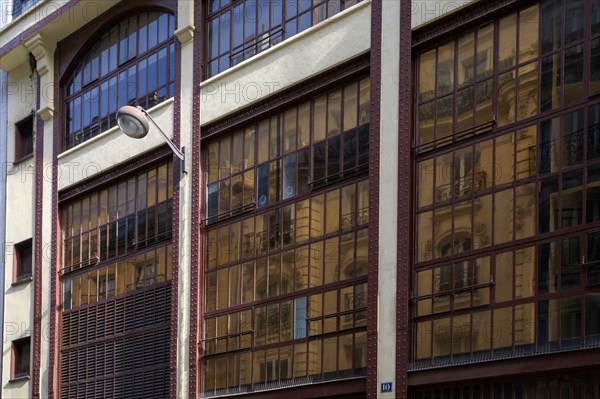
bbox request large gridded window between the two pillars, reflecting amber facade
[203,78,369,396]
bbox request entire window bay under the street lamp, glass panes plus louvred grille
[60,162,173,398]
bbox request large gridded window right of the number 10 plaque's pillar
[412,0,600,369]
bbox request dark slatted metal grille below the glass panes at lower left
[60,283,171,399]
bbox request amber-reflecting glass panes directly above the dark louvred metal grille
[61,163,173,310]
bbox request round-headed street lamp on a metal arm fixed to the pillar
[117,105,187,173]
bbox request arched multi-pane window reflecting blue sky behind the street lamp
[64,11,175,149]
